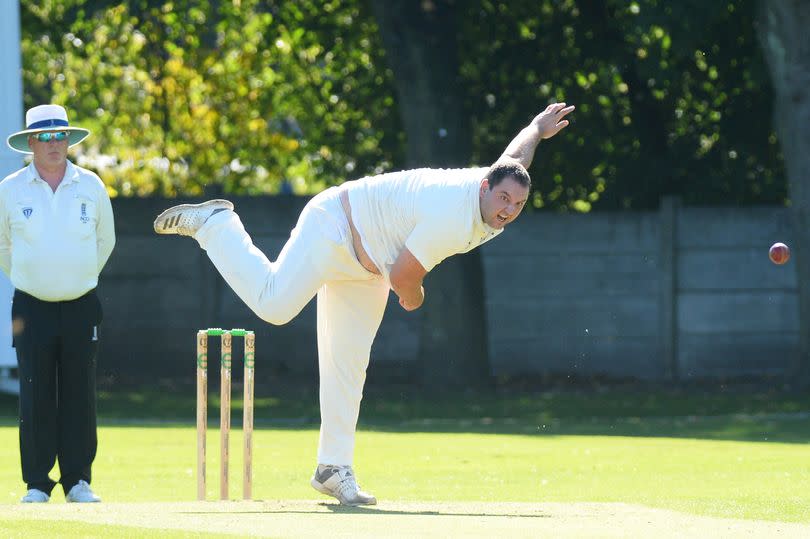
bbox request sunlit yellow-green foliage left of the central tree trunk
[23,0,399,196]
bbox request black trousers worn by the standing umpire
[11,290,102,494]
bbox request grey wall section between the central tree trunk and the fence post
[484,207,665,378]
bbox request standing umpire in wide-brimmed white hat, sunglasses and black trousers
[0,105,115,503]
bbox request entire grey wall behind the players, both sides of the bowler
[99,197,798,382]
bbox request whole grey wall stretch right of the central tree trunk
[484,200,798,379]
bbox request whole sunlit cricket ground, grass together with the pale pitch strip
[0,390,810,539]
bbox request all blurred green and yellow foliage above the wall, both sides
[15,0,787,211]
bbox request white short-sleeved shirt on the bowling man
[344,168,503,279]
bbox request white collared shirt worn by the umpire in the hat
[0,161,115,301]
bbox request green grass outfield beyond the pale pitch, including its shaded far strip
[0,390,810,537]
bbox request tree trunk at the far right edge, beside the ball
[751,0,810,386]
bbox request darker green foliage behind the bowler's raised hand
[460,0,786,210]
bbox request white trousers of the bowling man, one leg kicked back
[194,187,389,465]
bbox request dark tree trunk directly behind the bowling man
[372,0,489,389]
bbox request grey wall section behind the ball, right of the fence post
[677,208,799,377]
